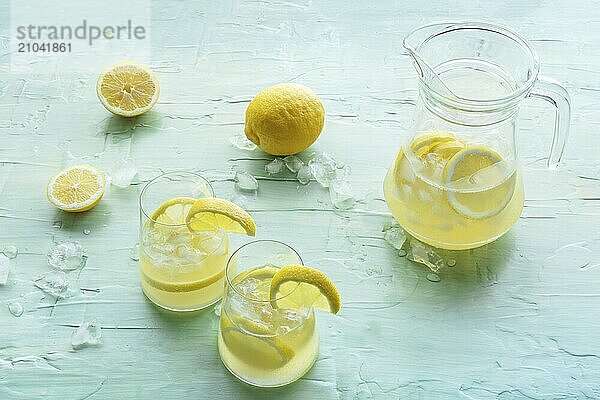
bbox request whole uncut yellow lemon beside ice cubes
[244,83,325,156]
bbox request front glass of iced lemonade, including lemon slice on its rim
[218,240,341,387]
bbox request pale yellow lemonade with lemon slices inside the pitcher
[384,132,523,250]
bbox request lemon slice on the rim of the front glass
[269,265,342,314]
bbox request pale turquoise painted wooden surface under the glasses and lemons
[0,0,600,400]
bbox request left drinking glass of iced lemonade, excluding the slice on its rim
[139,172,228,311]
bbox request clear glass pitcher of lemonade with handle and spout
[384,23,570,250]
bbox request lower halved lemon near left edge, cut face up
[46,165,106,212]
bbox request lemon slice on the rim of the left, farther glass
[185,197,256,236]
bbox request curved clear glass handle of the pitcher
[529,76,571,169]
